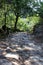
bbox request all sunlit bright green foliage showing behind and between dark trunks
[0,11,39,32]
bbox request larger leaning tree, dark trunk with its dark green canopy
[11,0,35,30]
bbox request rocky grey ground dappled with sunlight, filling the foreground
[0,32,43,65]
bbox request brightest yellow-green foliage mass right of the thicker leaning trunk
[17,16,39,32]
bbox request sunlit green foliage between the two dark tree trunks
[6,12,16,28]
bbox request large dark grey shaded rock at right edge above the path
[33,24,43,37]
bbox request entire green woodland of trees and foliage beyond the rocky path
[0,0,43,34]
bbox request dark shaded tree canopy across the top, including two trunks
[0,0,43,33]
